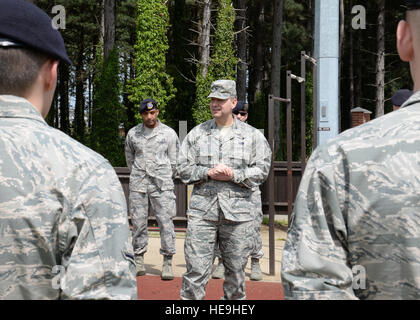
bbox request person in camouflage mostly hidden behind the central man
[212,101,264,281]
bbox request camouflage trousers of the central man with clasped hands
[181,217,253,300]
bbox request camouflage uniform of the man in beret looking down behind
[125,121,179,256]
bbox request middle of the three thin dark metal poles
[286,71,293,223]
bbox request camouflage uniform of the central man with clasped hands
[178,119,271,299]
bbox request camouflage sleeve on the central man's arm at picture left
[177,132,209,184]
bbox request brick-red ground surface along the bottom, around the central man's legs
[137,275,284,300]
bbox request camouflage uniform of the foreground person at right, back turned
[282,92,420,299]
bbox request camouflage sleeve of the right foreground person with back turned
[282,149,356,299]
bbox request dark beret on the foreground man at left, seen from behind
[0,0,71,64]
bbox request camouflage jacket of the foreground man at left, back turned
[0,95,137,299]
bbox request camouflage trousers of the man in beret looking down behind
[130,189,176,256]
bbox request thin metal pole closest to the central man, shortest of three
[268,95,276,276]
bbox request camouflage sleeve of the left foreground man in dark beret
[59,162,137,300]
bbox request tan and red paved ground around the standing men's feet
[137,225,286,300]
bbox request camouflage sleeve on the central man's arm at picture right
[233,130,271,188]
